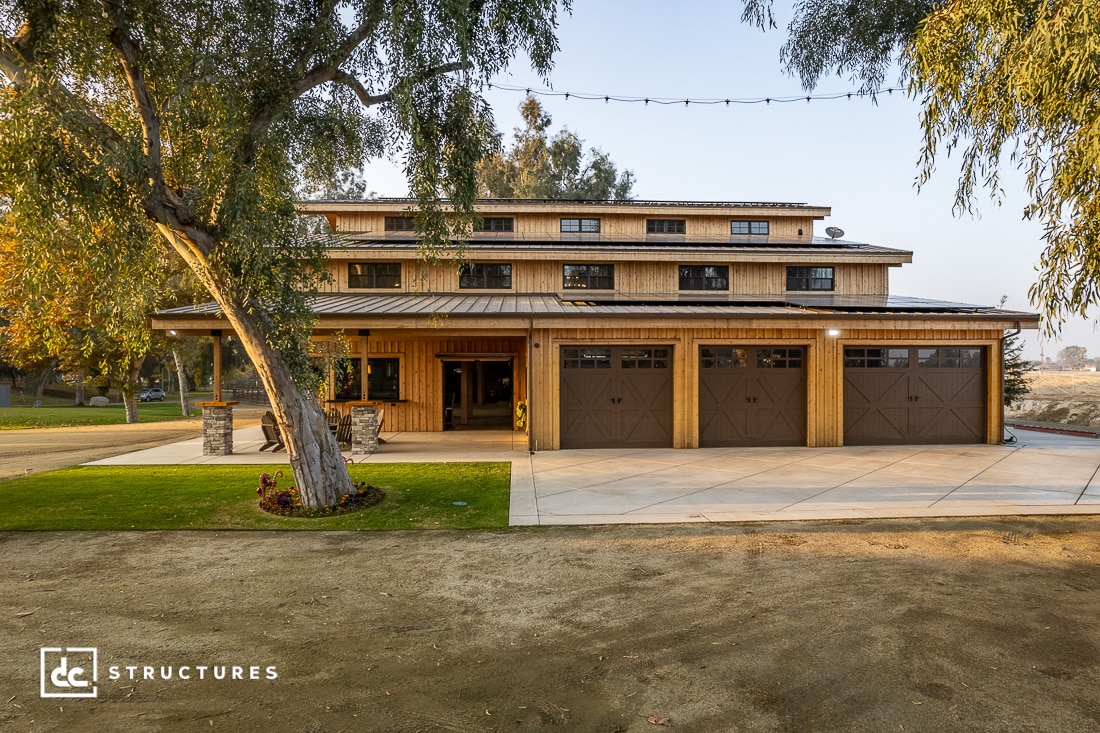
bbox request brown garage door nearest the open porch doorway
[561,346,672,448]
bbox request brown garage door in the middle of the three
[699,347,806,448]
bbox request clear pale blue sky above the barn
[366,0,1100,359]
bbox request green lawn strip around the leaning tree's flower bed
[0,463,509,529]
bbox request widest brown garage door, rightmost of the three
[844,347,986,446]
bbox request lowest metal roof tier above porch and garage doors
[155,292,1038,320]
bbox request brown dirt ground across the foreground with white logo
[0,517,1100,733]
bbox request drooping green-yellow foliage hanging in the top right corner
[745,0,1100,330]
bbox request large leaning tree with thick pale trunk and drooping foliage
[0,0,569,505]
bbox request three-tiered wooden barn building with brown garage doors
[154,199,1038,450]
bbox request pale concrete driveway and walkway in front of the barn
[83,427,1100,526]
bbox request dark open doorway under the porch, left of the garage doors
[443,355,515,430]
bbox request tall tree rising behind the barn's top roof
[477,97,635,200]
